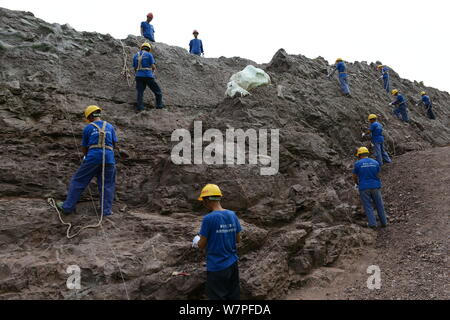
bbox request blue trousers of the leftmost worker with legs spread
[62,162,116,216]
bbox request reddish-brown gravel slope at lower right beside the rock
[287,147,450,300]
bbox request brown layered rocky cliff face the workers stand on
[0,9,450,299]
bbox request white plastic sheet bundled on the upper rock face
[225,65,270,97]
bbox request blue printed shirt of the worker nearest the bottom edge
[200,210,242,272]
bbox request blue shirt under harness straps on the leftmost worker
[81,120,117,164]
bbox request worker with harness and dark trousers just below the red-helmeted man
[133,43,164,111]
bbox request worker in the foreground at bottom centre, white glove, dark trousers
[193,184,242,300]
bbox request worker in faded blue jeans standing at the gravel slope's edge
[353,147,387,228]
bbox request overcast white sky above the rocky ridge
[0,0,450,92]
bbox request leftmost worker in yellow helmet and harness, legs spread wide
[56,106,117,216]
